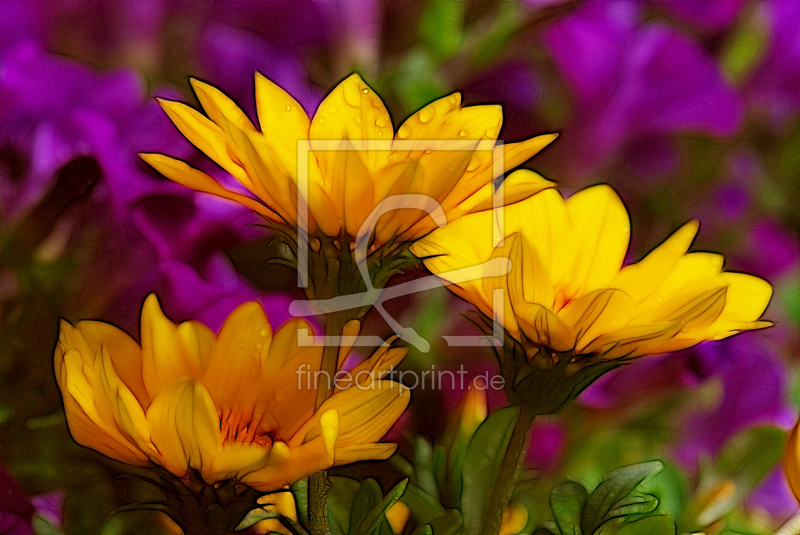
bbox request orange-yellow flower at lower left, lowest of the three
[55,295,410,491]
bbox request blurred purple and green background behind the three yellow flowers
[0,0,800,534]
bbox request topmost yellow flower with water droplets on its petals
[141,74,556,246]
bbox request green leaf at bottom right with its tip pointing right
[581,461,663,535]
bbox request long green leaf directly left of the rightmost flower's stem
[461,407,519,535]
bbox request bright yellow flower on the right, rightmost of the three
[411,185,772,359]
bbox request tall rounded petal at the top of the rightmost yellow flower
[567,185,631,294]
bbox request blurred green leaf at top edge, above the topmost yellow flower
[419,0,465,59]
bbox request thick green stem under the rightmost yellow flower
[482,406,536,535]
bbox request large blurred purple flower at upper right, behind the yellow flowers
[544,0,742,174]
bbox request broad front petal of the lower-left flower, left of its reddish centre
[147,378,222,476]
